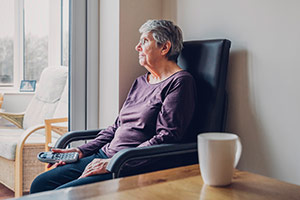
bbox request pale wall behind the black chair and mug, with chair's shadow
[164,0,300,184]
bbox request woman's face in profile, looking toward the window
[135,32,163,67]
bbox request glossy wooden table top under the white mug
[15,165,300,200]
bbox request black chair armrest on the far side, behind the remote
[54,129,102,149]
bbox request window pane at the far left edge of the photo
[0,0,15,85]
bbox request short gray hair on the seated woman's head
[139,19,183,62]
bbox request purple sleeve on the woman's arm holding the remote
[78,117,120,157]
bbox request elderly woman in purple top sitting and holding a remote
[30,20,196,193]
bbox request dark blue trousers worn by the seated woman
[30,150,112,194]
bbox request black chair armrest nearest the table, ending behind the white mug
[106,142,197,178]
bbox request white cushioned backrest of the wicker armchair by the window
[23,66,68,129]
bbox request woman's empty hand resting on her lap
[79,158,110,178]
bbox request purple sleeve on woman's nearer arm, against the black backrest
[139,77,196,147]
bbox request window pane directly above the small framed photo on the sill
[24,0,49,81]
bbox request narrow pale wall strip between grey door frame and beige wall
[99,0,120,128]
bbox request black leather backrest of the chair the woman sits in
[178,39,231,141]
